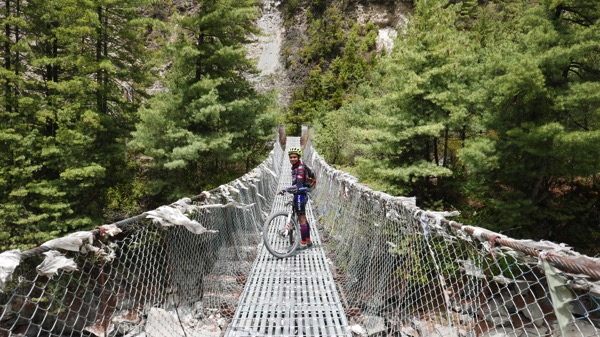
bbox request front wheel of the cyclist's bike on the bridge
[263,211,300,259]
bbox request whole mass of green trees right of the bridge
[314,0,600,250]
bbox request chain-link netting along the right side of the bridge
[304,137,600,337]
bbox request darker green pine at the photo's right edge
[462,0,600,245]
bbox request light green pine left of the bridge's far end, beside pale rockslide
[132,0,274,200]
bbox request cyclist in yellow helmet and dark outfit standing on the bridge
[279,147,312,249]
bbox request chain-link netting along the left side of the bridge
[0,143,283,337]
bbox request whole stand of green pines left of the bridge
[0,0,275,250]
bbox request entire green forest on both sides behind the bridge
[0,0,600,255]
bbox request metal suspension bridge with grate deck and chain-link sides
[0,130,600,337]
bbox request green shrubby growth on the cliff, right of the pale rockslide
[285,3,377,133]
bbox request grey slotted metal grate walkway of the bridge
[226,137,351,336]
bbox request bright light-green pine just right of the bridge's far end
[342,1,479,200]
